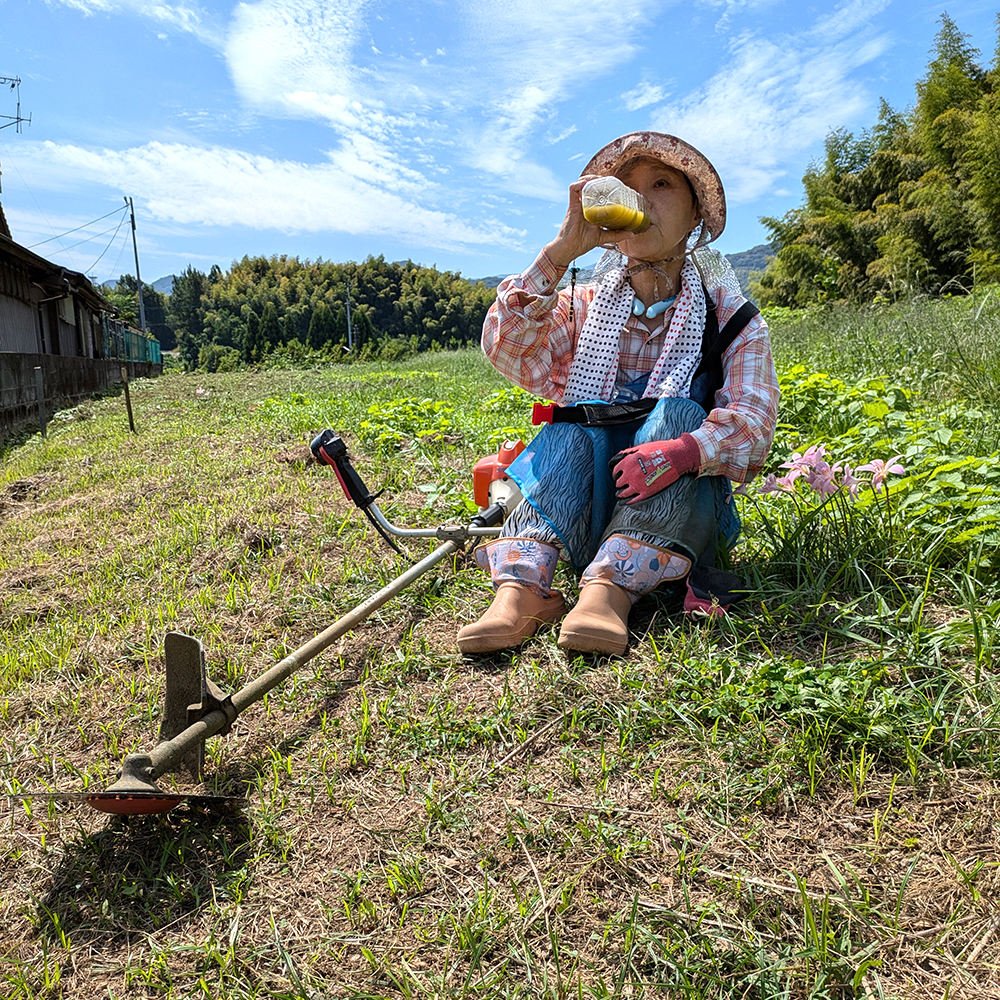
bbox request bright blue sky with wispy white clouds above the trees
[0,0,997,281]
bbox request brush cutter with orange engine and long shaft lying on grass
[13,430,524,815]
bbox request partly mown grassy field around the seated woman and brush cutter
[0,295,1000,1000]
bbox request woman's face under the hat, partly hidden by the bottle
[618,157,701,260]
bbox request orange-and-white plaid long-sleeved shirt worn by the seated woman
[483,251,778,482]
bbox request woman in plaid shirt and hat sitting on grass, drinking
[458,132,778,654]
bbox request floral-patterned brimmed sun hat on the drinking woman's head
[581,132,726,243]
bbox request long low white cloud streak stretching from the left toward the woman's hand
[15,142,523,249]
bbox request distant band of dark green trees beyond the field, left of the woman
[111,255,496,370]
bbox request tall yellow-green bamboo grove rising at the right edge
[751,14,1000,307]
